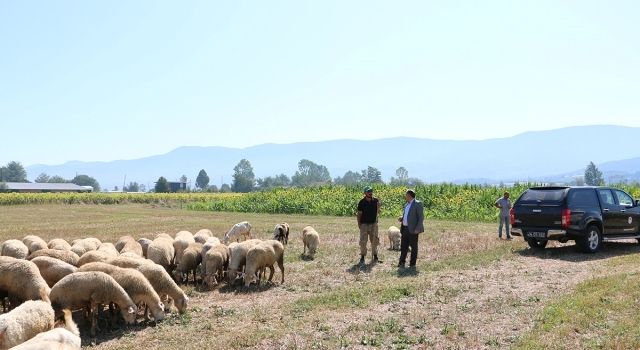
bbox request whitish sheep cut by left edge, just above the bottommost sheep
[0,300,54,349]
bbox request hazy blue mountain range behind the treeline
[27,125,640,189]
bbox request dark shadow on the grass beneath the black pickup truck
[514,242,640,262]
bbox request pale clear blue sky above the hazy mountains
[0,0,640,165]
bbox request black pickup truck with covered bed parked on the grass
[511,186,640,253]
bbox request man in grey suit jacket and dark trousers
[398,190,424,269]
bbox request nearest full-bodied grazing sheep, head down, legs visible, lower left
[51,271,138,338]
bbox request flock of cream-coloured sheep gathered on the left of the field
[0,222,320,350]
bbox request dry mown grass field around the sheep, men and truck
[0,204,640,350]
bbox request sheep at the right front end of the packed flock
[244,240,284,287]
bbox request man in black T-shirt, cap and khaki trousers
[357,186,380,264]
